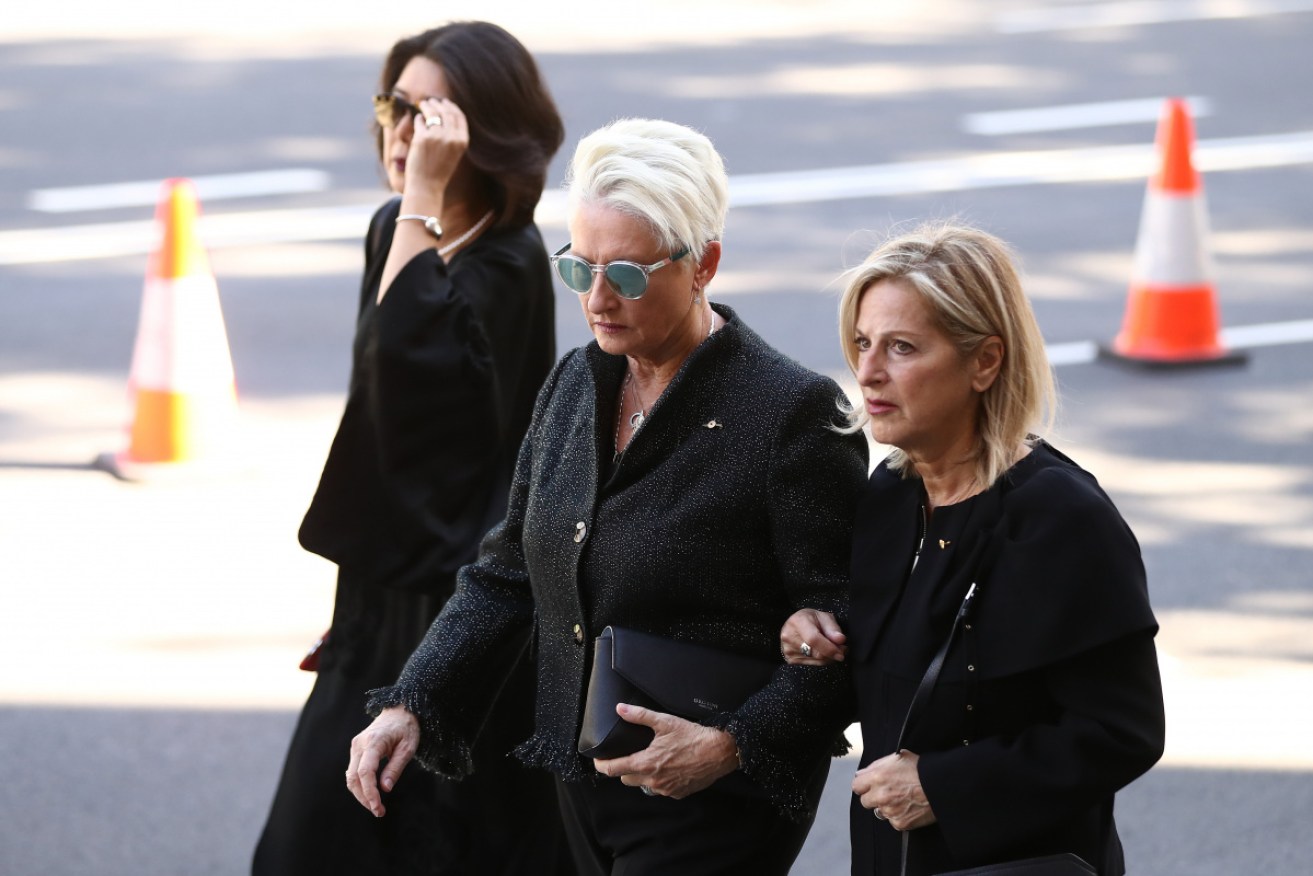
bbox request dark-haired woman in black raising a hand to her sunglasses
[253,22,563,876]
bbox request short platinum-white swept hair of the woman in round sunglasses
[566,118,729,260]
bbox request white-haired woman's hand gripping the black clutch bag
[593,703,738,800]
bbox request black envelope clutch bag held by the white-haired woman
[579,626,779,759]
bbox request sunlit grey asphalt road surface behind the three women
[0,0,1313,876]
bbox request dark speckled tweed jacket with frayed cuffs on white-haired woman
[370,306,867,813]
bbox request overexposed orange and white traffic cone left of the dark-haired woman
[97,180,236,481]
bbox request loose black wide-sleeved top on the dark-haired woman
[301,197,555,598]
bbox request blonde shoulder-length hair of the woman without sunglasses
[839,222,1057,489]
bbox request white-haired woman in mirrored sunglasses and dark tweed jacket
[348,120,867,876]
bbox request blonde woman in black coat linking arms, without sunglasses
[781,225,1163,876]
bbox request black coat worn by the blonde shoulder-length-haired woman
[848,443,1163,876]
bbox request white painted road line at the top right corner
[994,0,1313,33]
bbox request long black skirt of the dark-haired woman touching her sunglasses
[252,570,569,876]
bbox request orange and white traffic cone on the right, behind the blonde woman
[1100,99,1245,366]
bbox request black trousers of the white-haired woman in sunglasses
[557,764,829,876]
